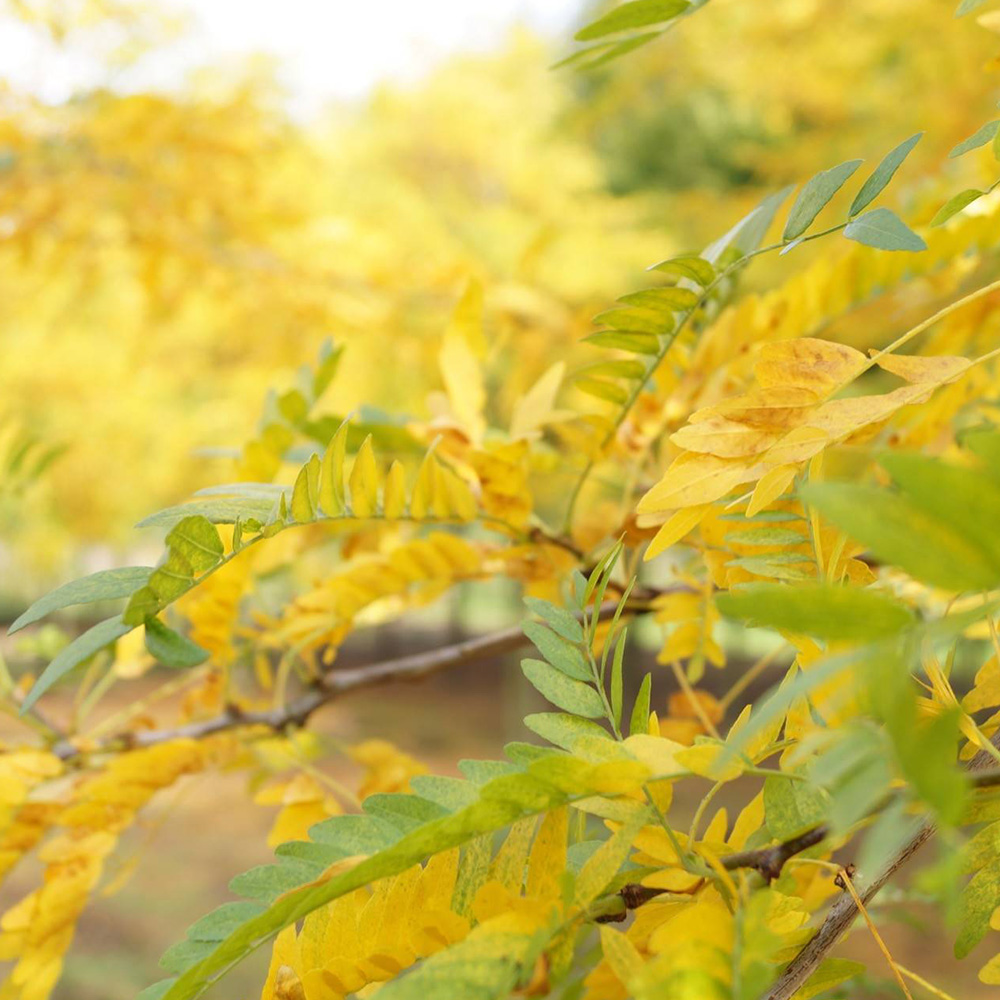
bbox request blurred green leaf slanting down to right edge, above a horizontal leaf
[800,483,1000,591]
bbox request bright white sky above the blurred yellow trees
[0,0,582,112]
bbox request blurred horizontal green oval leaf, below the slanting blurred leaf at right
[715,583,914,639]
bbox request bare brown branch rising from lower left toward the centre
[52,593,664,760]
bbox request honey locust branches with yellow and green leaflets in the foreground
[0,0,1000,1000]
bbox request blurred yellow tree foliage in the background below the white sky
[0,0,1000,596]
